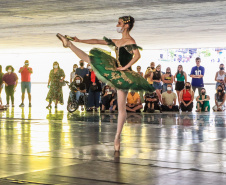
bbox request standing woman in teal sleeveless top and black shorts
[174,65,187,105]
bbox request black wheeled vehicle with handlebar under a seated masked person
[66,82,88,113]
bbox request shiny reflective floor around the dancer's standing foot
[0,108,226,185]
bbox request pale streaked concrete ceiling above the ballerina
[0,0,226,49]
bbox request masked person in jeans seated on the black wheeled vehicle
[69,75,86,110]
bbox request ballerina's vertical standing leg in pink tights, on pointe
[114,90,128,151]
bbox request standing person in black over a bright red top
[87,69,102,112]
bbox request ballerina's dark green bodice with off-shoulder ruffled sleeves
[103,37,142,70]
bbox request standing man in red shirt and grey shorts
[19,60,33,107]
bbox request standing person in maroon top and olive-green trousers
[2,66,18,107]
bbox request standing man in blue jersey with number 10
[190,57,205,96]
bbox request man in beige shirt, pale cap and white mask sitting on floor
[161,84,179,111]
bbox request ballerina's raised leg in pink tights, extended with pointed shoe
[56,33,90,64]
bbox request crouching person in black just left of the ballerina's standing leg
[101,85,112,113]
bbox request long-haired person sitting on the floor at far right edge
[213,85,225,111]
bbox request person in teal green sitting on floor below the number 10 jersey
[196,88,210,112]
